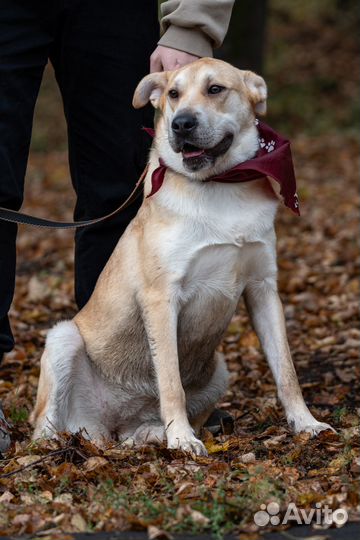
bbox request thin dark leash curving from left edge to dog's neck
[0,166,148,229]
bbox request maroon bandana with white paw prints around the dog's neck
[144,120,300,215]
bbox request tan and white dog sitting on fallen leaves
[32,59,331,454]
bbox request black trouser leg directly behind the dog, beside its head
[51,0,159,307]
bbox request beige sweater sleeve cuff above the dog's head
[159,0,235,56]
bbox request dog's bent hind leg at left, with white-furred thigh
[31,321,110,439]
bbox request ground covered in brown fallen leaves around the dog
[0,0,360,540]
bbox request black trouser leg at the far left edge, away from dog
[0,0,52,357]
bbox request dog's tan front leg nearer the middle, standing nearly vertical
[140,289,207,455]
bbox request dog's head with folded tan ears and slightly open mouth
[133,58,267,179]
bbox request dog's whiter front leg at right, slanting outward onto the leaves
[245,278,332,435]
